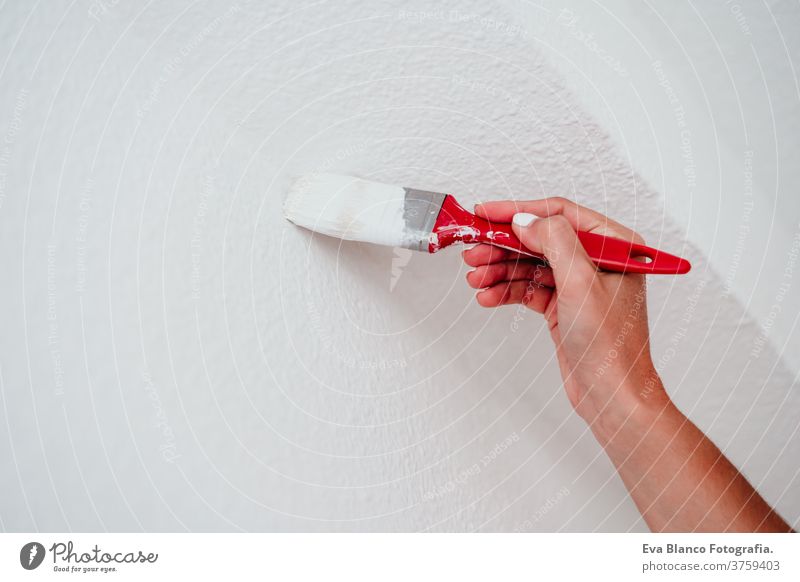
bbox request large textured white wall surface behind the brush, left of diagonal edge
[0,0,800,531]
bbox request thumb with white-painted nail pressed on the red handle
[511,212,597,295]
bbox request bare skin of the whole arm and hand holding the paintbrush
[463,198,791,532]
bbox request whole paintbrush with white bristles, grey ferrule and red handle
[284,174,691,275]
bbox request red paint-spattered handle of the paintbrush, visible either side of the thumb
[428,195,692,275]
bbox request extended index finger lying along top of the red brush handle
[475,196,644,244]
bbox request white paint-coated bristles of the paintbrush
[284,174,408,246]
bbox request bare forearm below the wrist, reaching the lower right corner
[592,380,790,532]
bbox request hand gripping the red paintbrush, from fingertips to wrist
[463,198,668,432]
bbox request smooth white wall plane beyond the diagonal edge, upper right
[514,0,800,373]
